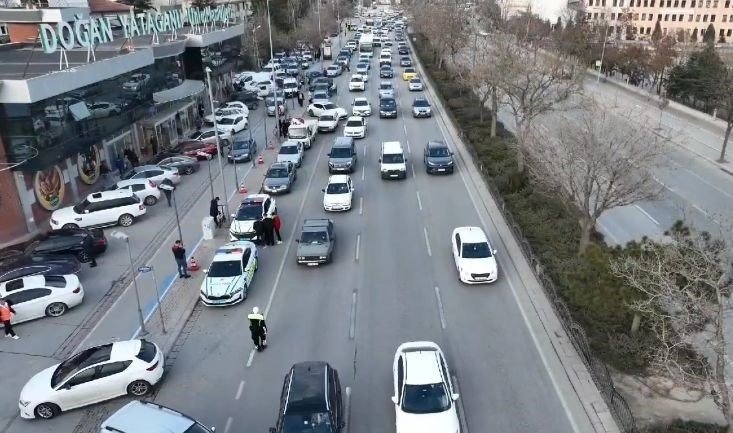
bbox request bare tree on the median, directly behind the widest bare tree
[494,37,583,173]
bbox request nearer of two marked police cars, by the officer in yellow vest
[200,241,259,307]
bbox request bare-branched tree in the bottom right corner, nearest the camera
[611,224,733,432]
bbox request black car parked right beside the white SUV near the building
[25,228,107,263]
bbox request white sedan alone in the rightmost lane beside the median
[451,227,499,284]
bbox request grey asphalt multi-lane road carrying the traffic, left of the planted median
[3,28,589,433]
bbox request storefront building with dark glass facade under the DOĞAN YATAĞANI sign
[0,2,244,248]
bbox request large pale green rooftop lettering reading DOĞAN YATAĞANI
[38,5,234,54]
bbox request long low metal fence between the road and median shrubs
[424,68,639,433]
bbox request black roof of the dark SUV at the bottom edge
[285,361,330,414]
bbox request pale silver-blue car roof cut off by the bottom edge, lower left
[101,400,195,433]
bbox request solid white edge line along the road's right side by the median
[428,87,580,433]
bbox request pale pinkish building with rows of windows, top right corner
[583,0,733,43]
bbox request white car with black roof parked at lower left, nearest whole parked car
[18,340,165,419]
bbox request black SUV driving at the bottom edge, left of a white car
[270,361,346,433]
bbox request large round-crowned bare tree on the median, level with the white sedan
[529,100,662,254]
